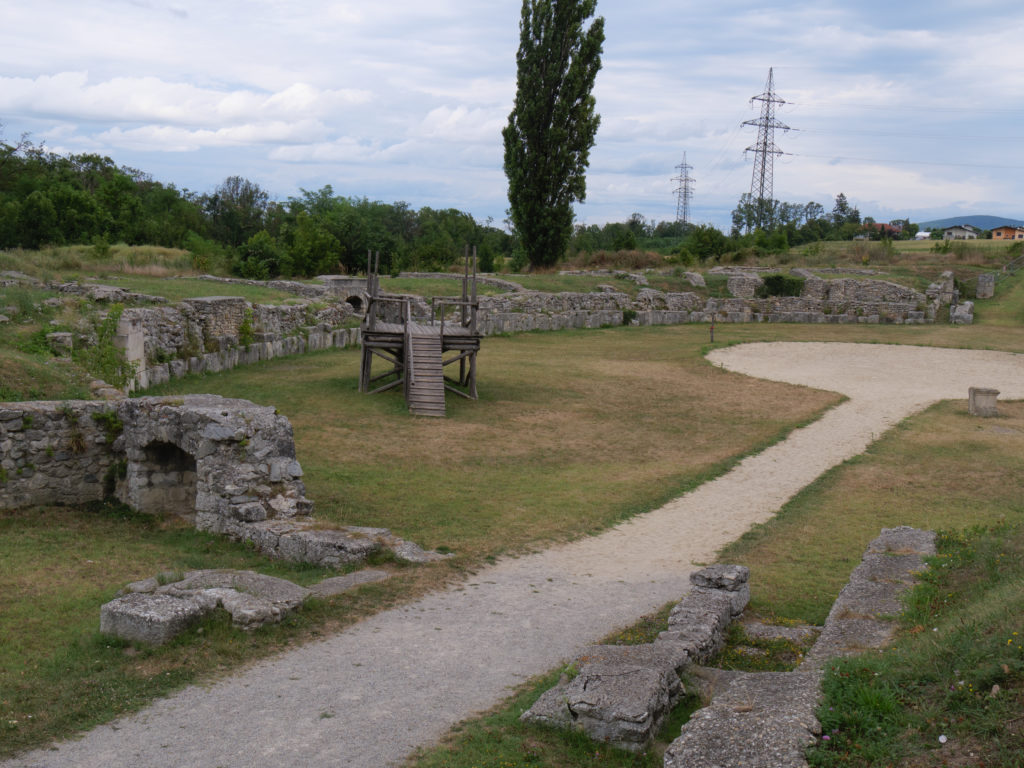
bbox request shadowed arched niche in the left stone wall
[126,440,198,518]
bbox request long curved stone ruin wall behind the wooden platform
[110,272,940,389]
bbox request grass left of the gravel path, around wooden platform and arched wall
[0,328,838,754]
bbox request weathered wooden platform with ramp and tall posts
[359,247,481,417]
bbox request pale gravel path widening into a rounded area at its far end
[9,343,1024,768]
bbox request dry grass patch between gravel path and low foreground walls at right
[723,400,1024,624]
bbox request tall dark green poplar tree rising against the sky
[502,0,604,266]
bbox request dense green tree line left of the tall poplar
[0,136,512,278]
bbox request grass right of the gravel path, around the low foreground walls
[409,402,1024,768]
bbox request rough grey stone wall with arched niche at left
[0,395,312,539]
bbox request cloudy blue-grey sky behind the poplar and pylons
[0,0,1024,228]
